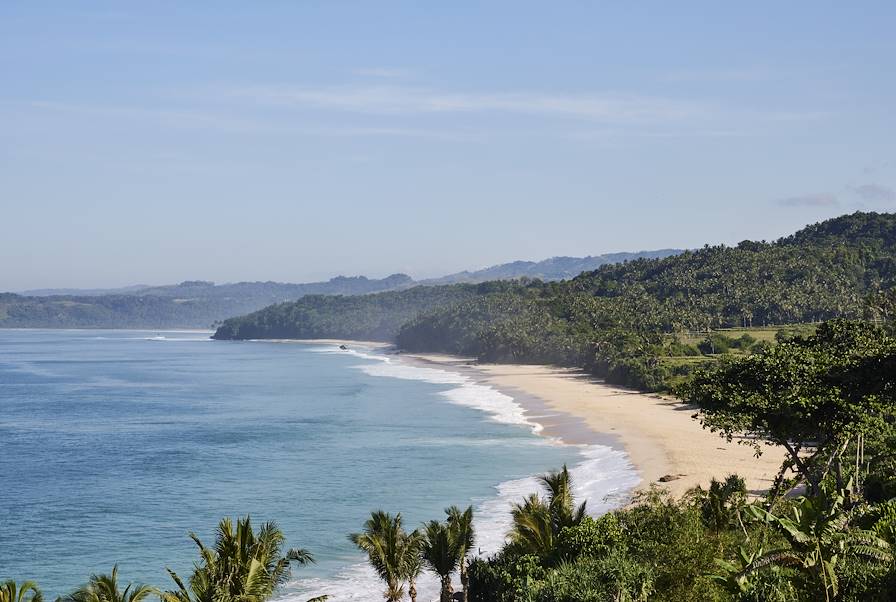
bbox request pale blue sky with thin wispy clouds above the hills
[0,0,896,291]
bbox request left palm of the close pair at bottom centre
[348,510,420,602]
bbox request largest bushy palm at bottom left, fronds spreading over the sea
[162,516,323,602]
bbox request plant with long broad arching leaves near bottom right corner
[742,484,893,600]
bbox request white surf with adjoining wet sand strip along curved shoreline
[284,339,640,602]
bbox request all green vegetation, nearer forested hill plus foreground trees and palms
[7,214,896,602]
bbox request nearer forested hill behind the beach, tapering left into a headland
[215,213,896,388]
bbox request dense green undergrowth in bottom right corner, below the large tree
[470,477,896,602]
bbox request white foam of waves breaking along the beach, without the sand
[280,346,640,602]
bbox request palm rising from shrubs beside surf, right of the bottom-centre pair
[510,464,585,558]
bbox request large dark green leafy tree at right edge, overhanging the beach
[677,320,896,492]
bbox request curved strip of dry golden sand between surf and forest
[402,354,784,496]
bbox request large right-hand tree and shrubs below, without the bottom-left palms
[470,320,896,602]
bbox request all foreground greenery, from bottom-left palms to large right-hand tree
[0,316,896,602]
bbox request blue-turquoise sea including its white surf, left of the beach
[0,330,637,601]
